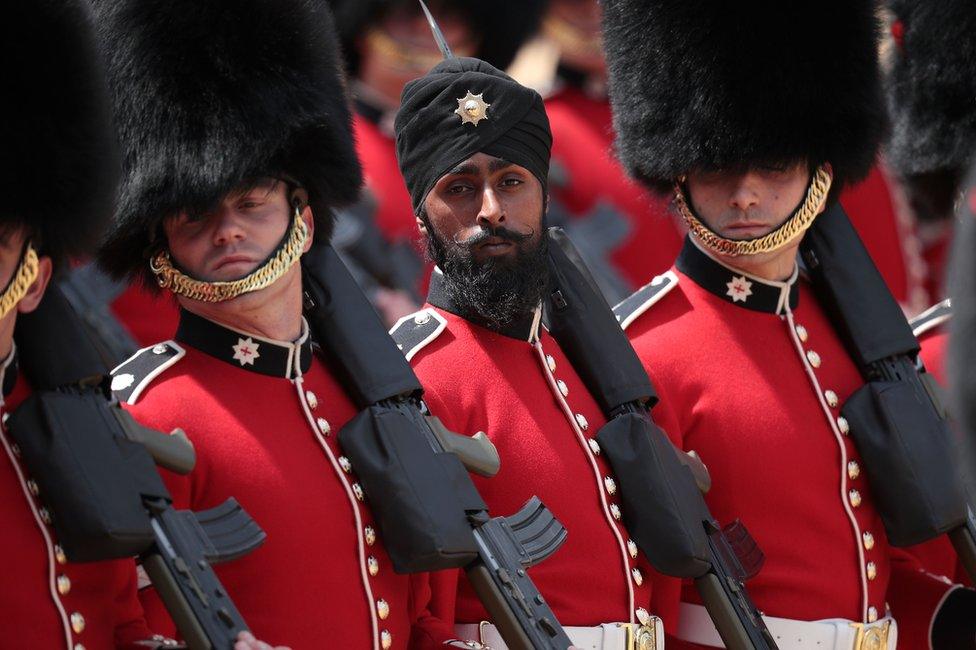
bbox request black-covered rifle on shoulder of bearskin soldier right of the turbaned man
[800,203,976,579]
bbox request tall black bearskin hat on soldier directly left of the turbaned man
[95,0,362,285]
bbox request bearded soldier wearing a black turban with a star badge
[392,52,677,649]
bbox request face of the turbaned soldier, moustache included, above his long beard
[419,153,544,263]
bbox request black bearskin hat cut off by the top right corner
[886,0,976,181]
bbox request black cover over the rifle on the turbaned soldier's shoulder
[545,228,710,578]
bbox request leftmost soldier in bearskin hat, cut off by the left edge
[0,0,159,650]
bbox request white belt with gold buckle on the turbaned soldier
[454,616,664,650]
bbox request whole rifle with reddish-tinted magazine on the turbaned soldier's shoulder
[545,228,776,650]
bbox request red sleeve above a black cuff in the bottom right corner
[888,548,960,648]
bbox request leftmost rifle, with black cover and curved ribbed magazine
[8,286,265,650]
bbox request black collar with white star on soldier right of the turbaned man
[675,235,800,314]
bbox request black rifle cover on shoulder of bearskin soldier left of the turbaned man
[302,244,487,573]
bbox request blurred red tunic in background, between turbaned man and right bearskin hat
[546,85,681,288]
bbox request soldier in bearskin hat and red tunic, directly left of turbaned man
[91,0,453,650]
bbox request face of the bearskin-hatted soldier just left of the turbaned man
[163,179,313,282]
